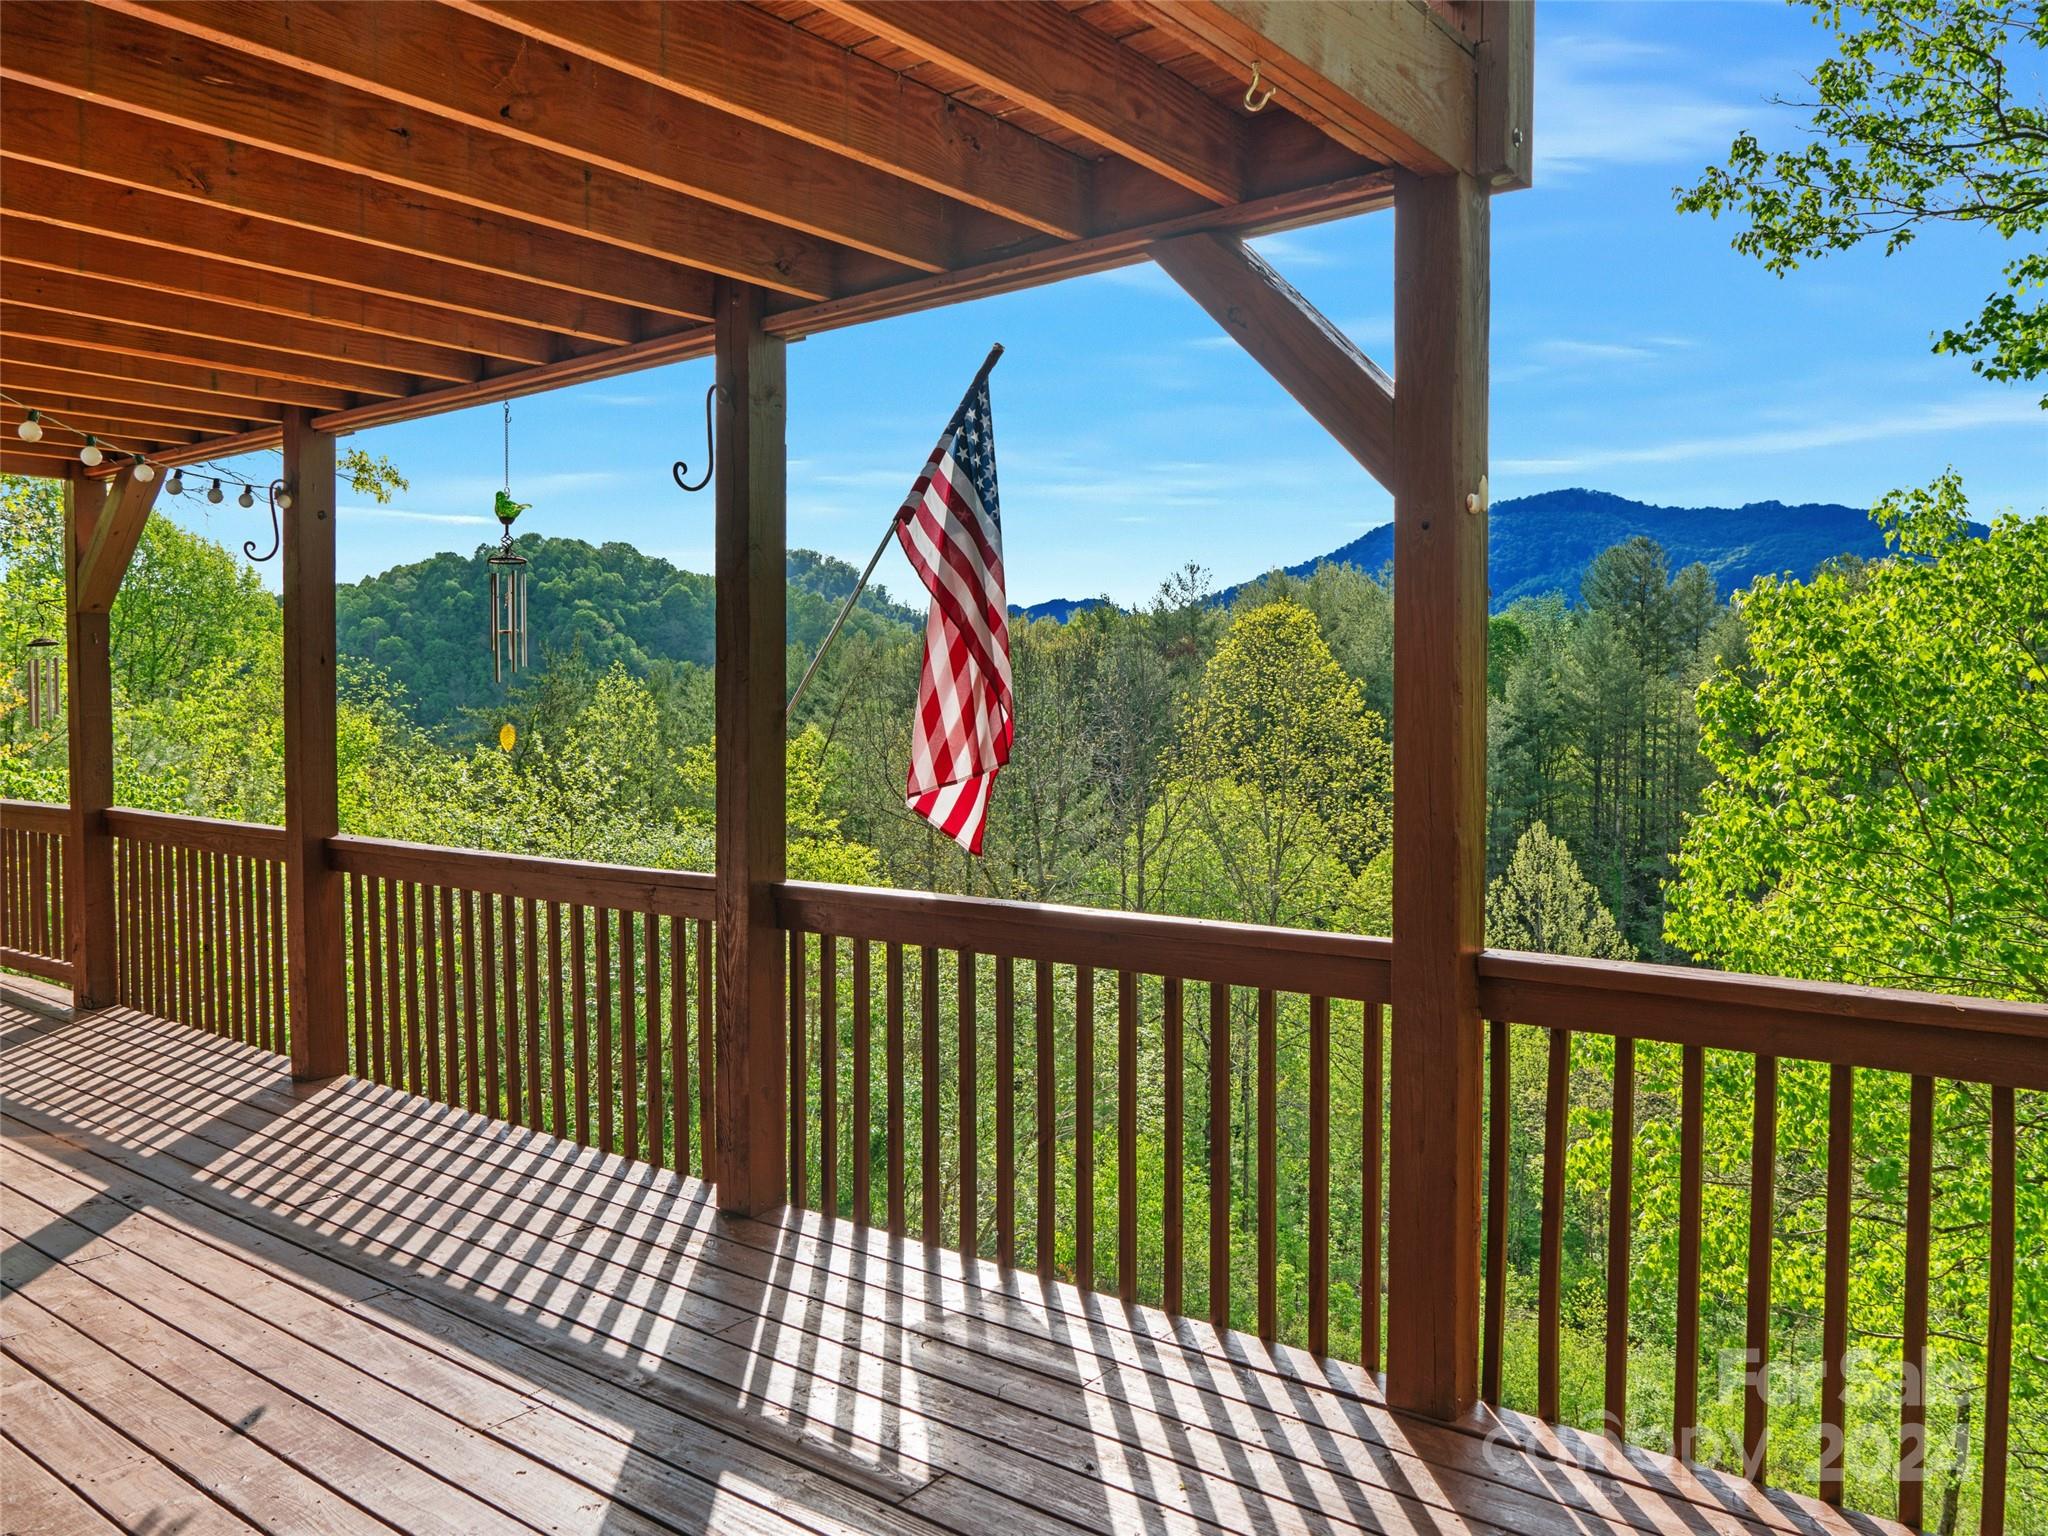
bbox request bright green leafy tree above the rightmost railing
[1665,473,2048,1001]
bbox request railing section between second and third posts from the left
[330,838,715,1178]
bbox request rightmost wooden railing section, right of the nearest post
[1479,950,2048,1532]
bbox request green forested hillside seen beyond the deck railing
[0,473,2048,1530]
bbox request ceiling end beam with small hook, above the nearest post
[1139,0,1477,174]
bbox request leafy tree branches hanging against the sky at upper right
[1675,0,2048,403]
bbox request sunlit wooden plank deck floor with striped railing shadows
[0,993,1880,1536]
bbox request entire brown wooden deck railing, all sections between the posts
[12,803,2048,1532]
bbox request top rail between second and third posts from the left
[328,836,717,918]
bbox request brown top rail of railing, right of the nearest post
[1479,950,2048,1087]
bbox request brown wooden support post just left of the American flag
[713,281,788,1214]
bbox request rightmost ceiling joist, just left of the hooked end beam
[819,0,1245,203]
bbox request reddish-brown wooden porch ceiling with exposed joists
[0,0,1530,475]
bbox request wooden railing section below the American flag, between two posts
[778,883,1391,1368]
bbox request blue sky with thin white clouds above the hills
[174,0,2048,602]
